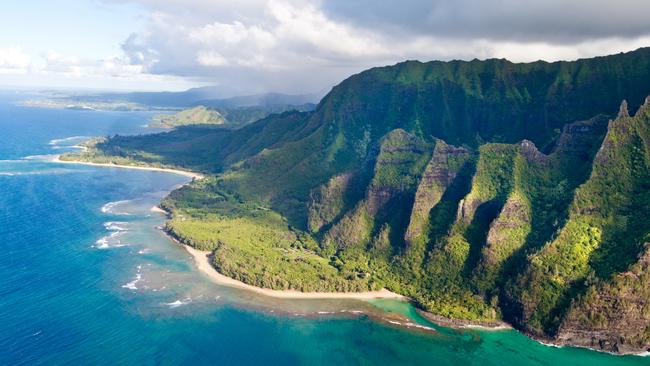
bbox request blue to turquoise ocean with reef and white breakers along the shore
[0,94,650,365]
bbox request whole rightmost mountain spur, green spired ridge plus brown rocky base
[510,97,650,340]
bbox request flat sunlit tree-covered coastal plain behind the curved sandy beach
[162,179,374,292]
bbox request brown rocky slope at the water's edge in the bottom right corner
[557,244,650,353]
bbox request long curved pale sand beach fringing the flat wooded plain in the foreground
[181,244,406,300]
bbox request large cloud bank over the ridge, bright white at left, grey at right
[106,0,650,92]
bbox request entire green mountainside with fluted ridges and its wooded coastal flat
[63,49,650,352]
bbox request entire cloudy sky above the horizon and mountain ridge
[0,0,650,95]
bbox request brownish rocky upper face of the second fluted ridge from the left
[404,140,472,245]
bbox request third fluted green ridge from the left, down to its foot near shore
[416,144,518,321]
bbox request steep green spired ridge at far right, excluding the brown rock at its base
[506,99,650,336]
